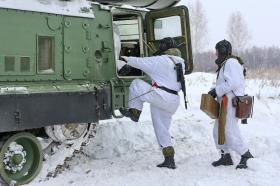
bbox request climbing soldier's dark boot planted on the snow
[157,146,176,169]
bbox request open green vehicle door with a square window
[145,6,193,74]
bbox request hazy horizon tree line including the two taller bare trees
[189,0,280,72]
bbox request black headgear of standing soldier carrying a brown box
[215,39,232,67]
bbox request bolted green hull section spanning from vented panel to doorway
[64,5,116,80]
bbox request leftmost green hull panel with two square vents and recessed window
[0,8,63,81]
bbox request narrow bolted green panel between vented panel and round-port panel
[64,17,92,79]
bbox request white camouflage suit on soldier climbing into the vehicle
[123,55,185,148]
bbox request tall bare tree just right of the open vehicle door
[190,0,208,54]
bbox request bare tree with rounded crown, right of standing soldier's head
[227,11,251,52]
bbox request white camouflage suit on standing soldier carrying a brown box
[213,58,248,155]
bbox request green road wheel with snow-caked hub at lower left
[0,132,43,185]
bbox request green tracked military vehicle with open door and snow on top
[0,0,193,185]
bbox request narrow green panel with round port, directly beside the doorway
[89,5,116,80]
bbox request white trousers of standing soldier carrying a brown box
[213,93,248,155]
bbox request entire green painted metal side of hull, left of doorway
[0,3,115,81]
